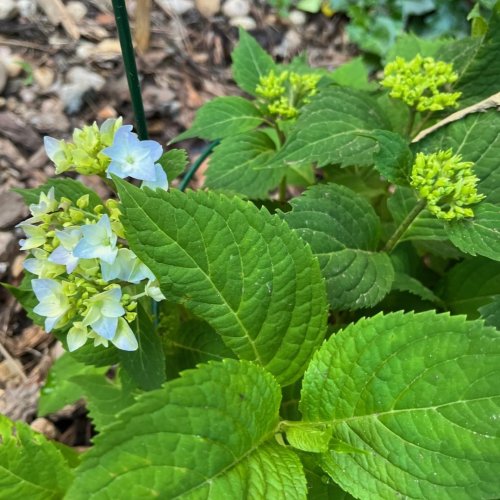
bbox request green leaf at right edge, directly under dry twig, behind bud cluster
[415,110,500,204]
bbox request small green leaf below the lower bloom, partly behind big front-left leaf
[70,374,135,432]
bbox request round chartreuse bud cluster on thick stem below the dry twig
[411,149,485,221]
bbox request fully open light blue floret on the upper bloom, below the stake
[102,126,163,181]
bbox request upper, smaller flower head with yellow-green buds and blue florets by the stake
[44,118,168,190]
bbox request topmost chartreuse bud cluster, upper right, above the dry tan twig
[380,54,461,111]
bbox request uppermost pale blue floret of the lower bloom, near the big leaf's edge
[73,215,118,264]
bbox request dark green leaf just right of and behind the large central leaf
[283,184,394,309]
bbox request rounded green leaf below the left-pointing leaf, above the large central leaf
[205,130,284,199]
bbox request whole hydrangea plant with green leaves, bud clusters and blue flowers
[0,14,500,500]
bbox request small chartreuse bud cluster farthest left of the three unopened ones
[255,70,320,120]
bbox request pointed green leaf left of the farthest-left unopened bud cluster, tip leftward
[171,97,262,142]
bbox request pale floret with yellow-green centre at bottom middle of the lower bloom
[83,287,125,340]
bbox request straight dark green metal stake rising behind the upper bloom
[113,0,148,140]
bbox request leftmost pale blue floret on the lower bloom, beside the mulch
[31,279,70,332]
